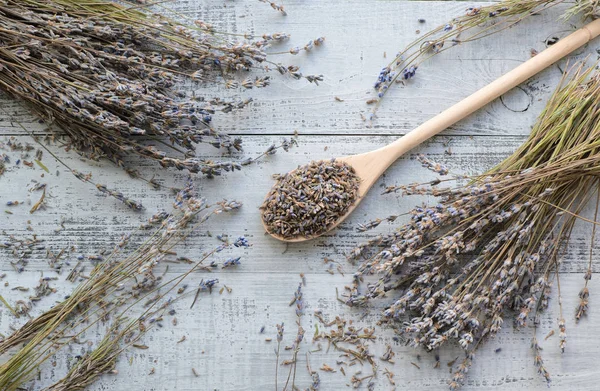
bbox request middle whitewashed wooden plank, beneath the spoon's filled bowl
[0,134,597,274]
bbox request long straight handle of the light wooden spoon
[382,19,600,165]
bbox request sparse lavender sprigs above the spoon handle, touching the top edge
[369,0,597,113]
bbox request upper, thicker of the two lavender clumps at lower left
[0,181,240,390]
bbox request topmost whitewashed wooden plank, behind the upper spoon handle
[0,0,598,135]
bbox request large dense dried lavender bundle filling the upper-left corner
[0,0,323,176]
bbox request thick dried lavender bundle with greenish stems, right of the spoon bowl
[348,67,600,389]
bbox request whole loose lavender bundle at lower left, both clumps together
[0,182,247,390]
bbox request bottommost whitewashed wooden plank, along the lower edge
[0,272,600,391]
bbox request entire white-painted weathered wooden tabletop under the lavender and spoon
[0,0,600,391]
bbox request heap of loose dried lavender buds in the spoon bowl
[260,159,360,239]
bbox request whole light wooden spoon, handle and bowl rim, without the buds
[261,19,600,242]
